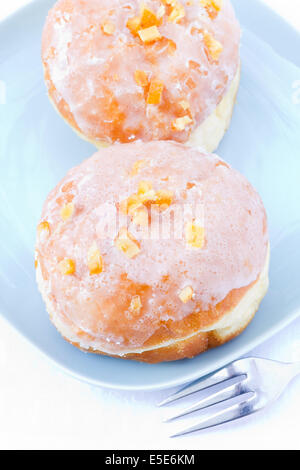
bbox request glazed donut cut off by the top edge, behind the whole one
[42,0,240,151]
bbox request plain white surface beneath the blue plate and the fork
[0,0,300,450]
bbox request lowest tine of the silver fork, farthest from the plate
[170,392,257,438]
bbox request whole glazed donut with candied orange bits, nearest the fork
[36,141,269,362]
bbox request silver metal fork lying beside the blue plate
[158,357,300,437]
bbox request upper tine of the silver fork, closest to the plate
[157,366,237,406]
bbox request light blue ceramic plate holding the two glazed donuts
[0,0,300,390]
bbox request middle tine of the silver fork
[164,374,247,423]
